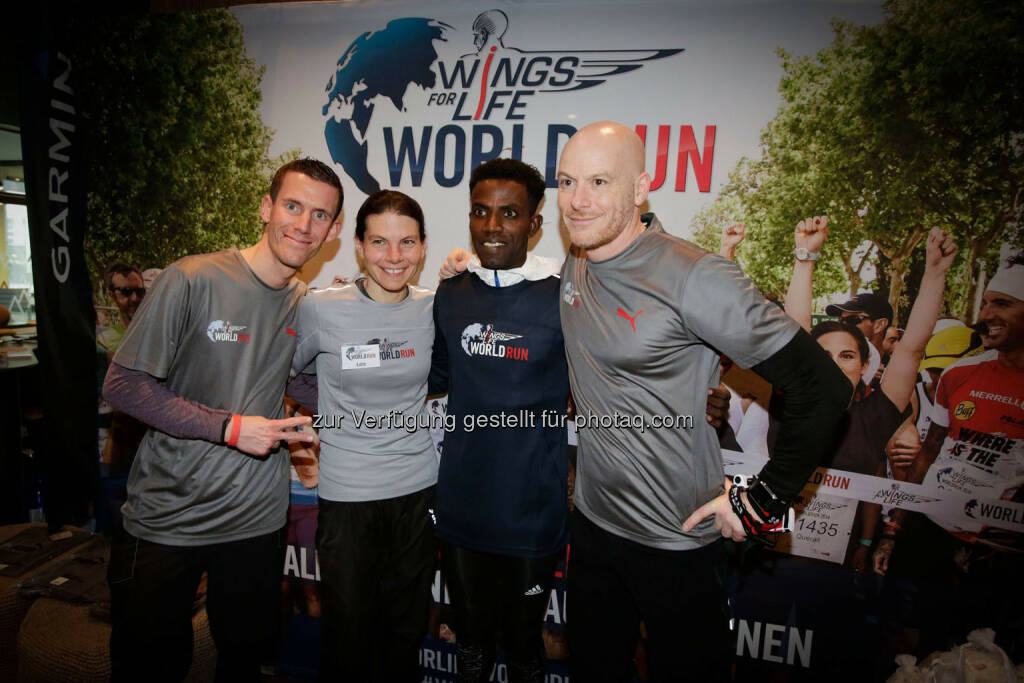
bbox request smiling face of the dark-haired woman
[355,213,426,303]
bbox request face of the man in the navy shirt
[469,179,541,270]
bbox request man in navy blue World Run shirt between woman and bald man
[431,159,728,682]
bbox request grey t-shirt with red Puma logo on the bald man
[560,215,799,550]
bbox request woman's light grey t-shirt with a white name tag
[292,284,437,502]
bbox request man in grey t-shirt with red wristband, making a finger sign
[103,159,342,681]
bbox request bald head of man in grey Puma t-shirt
[558,121,650,261]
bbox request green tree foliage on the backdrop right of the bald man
[694,0,1024,317]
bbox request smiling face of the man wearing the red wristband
[260,171,341,278]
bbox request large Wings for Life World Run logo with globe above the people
[322,9,716,195]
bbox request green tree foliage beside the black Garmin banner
[75,10,278,290]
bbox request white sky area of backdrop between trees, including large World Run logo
[232,0,881,288]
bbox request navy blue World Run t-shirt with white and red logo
[430,272,569,558]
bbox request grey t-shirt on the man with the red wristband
[114,249,306,546]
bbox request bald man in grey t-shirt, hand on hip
[558,122,853,681]
